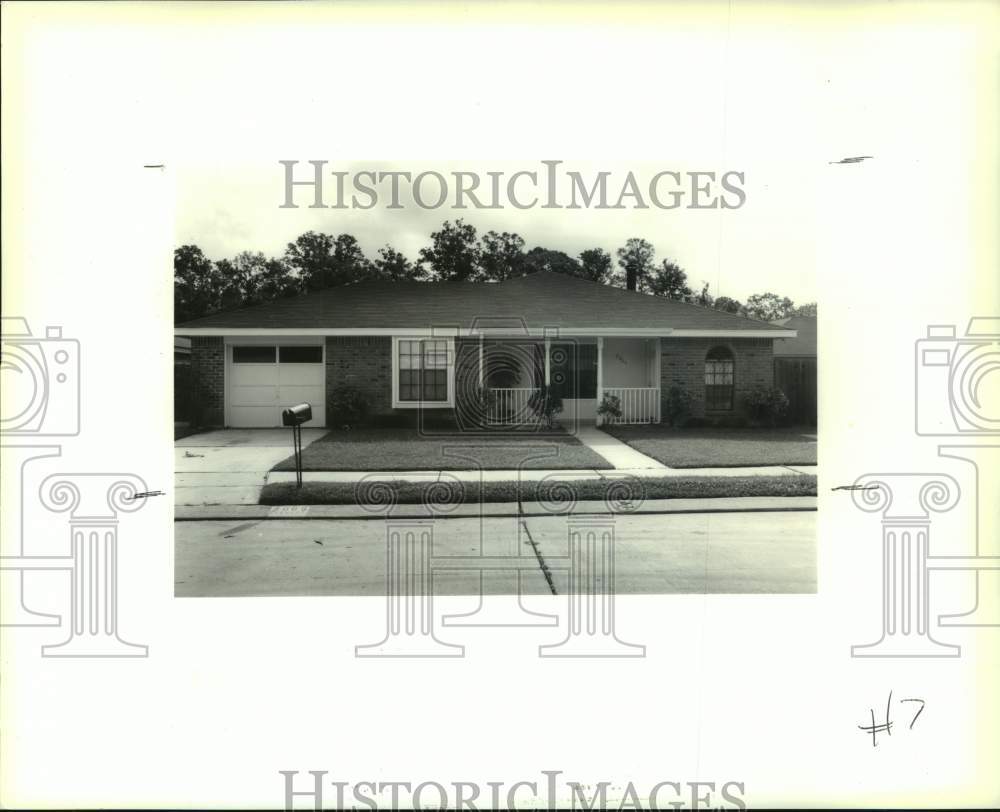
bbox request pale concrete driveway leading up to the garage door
[174,428,326,505]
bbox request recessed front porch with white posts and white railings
[477,337,661,426]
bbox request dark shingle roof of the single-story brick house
[178,271,784,333]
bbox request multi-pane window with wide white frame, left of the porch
[392,338,454,408]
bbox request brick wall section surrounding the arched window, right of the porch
[660,338,774,419]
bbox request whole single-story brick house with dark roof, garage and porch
[175,271,795,427]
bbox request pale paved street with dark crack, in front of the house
[174,511,816,597]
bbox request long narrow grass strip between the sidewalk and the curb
[260,474,816,505]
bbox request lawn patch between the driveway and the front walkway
[271,428,612,471]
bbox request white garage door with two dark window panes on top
[228,343,326,428]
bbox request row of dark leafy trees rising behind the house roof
[174,220,816,322]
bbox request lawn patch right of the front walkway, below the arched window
[603,425,816,468]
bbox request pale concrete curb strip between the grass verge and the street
[174,496,816,522]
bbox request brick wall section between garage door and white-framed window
[326,336,392,420]
